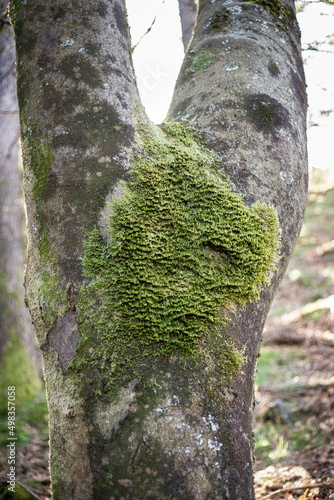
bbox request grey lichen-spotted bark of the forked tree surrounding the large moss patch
[12,0,307,500]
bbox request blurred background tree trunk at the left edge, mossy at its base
[0,1,41,401]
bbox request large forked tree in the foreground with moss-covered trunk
[11,0,307,500]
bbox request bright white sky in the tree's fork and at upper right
[126,0,334,171]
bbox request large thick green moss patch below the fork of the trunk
[75,123,279,396]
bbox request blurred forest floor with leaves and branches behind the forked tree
[0,171,334,500]
